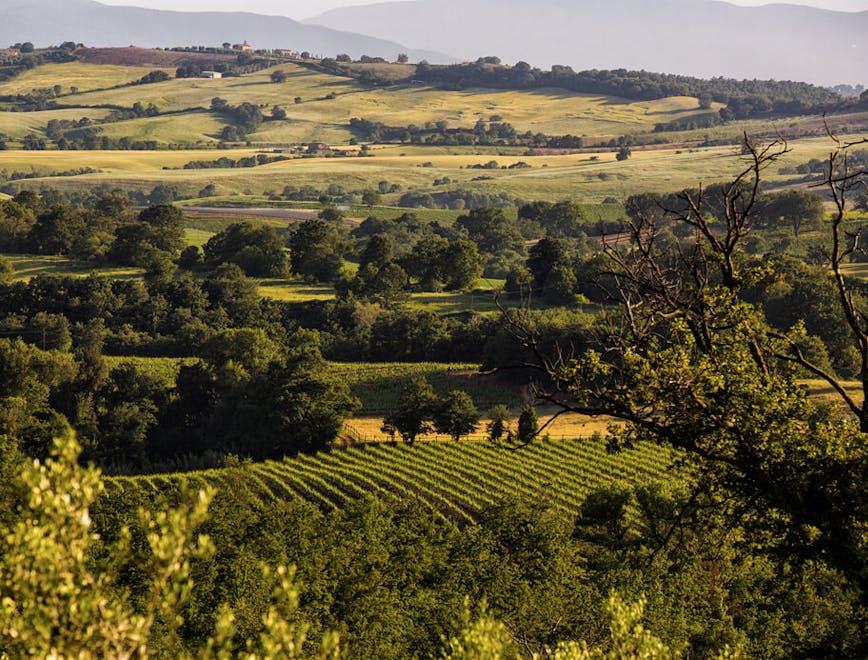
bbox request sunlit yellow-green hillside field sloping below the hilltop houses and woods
[57,64,722,142]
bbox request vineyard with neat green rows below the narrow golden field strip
[108,438,677,523]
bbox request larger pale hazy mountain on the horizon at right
[309,0,868,84]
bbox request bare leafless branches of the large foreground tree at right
[498,135,790,444]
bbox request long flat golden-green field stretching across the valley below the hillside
[0,138,856,203]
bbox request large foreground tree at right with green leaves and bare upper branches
[502,135,868,602]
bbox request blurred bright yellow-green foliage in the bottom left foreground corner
[0,437,337,658]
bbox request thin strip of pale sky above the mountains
[93,0,868,19]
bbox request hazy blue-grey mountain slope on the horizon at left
[0,0,452,62]
